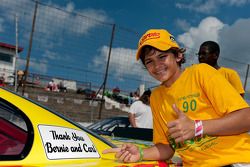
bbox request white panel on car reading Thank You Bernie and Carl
[38,125,100,159]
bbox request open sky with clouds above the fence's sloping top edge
[42,0,250,63]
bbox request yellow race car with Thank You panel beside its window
[0,88,181,167]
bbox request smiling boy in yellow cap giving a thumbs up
[103,29,250,166]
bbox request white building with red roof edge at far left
[0,42,23,84]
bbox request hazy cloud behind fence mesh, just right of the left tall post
[36,2,108,37]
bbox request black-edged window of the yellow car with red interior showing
[0,98,33,160]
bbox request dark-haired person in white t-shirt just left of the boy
[129,90,153,129]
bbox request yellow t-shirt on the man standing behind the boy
[218,67,245,94]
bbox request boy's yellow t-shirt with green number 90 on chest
[150,64,250,166]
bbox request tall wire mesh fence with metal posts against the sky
[0,0,250,120]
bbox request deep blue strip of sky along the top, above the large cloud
[46,0,250,35]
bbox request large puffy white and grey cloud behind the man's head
[177,17,250,89]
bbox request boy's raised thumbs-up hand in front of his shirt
[167,104,195,143]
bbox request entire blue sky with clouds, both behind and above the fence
[0,0,250,92]
